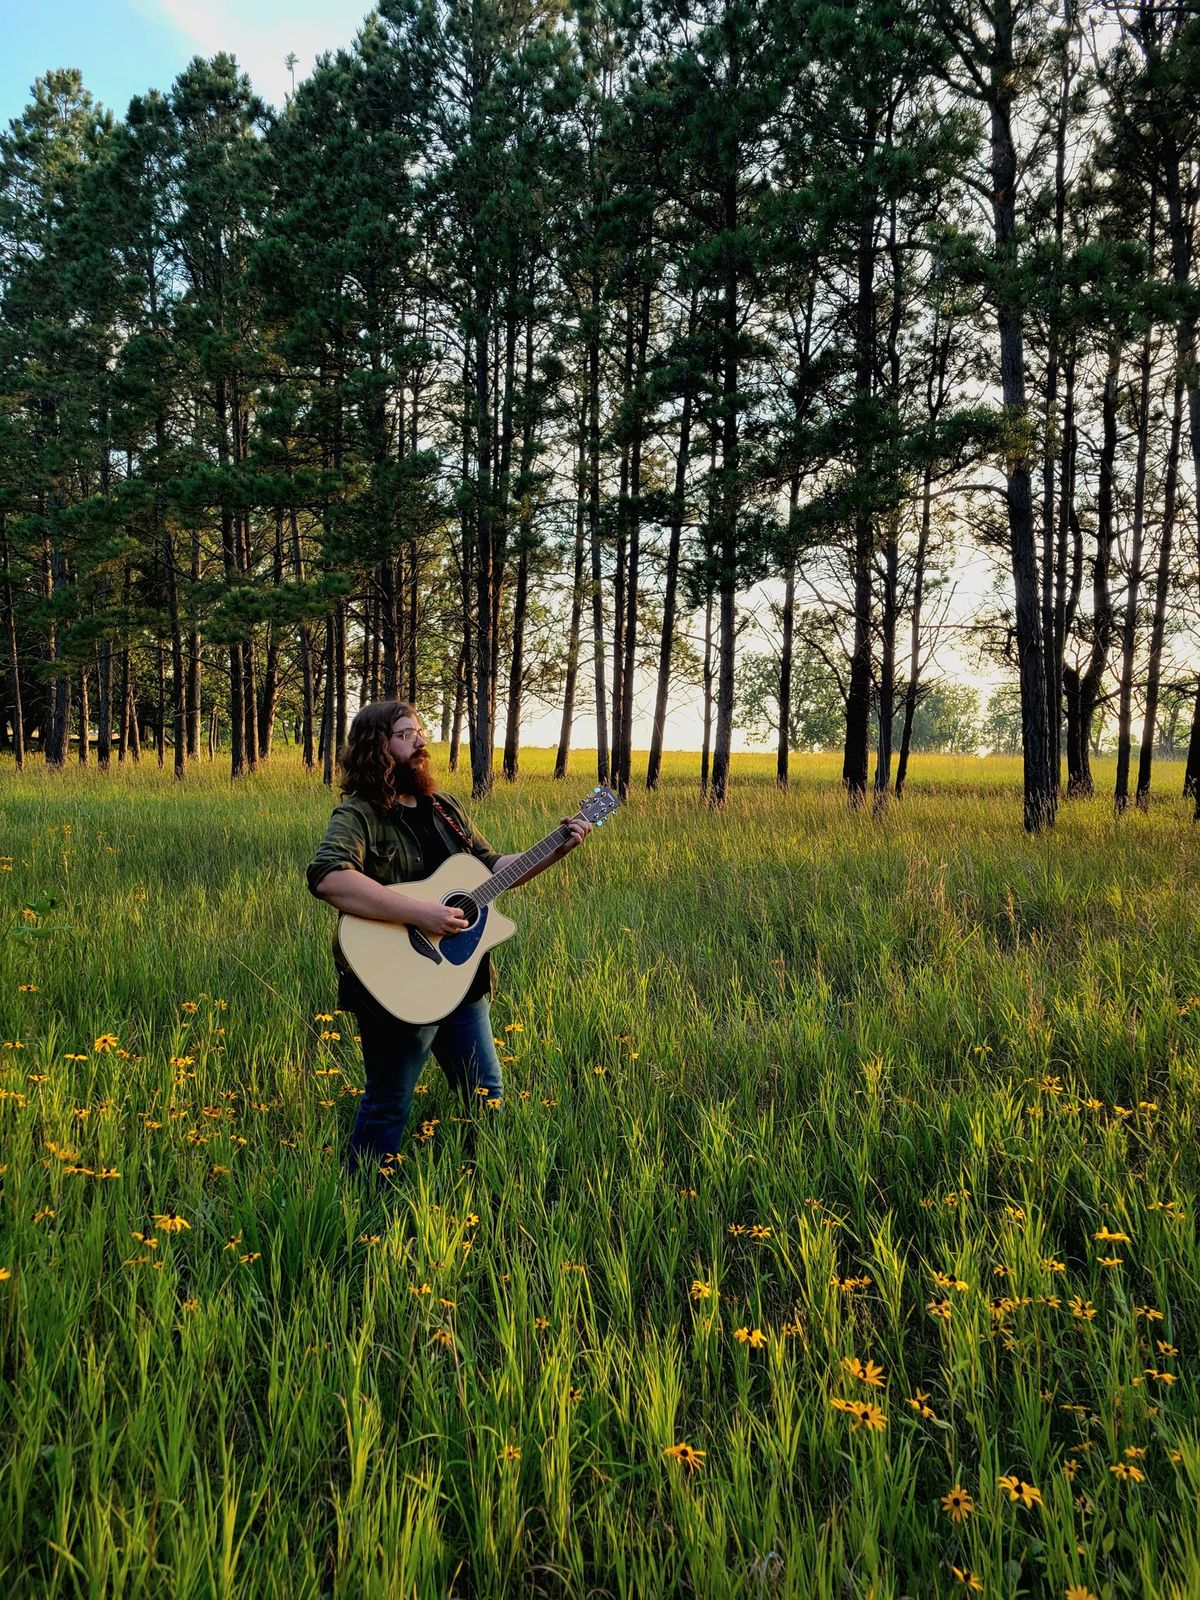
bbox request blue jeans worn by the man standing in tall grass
[338,973,504,1171]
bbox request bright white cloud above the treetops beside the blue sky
[136,0,370,106]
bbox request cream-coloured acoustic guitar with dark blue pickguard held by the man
[338,787,621,1024]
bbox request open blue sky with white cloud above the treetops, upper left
[0,0,370,126]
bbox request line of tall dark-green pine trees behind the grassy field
[0,0,1200,829]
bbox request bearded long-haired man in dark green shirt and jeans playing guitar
[307,701,592,1171]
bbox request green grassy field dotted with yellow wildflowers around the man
[0,752,1200,1600]
